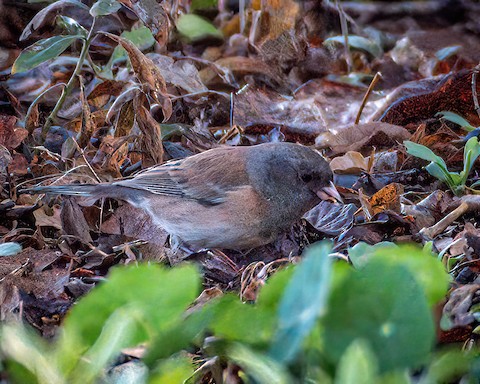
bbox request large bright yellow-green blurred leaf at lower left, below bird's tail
[56,265,200,371]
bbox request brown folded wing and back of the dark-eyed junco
[110,147,249,205]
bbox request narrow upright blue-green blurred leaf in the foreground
[270,241,331,363]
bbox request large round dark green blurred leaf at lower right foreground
[321,255,435,372]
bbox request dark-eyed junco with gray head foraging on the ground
[25,143,338,250]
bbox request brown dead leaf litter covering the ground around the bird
[0,0,480,380]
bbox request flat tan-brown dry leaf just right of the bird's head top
[315,121,411,154]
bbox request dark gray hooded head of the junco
[247,143,333,217]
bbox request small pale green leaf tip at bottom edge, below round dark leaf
[335,340,378,384]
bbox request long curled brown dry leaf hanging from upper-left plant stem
[102,32,172,121]
